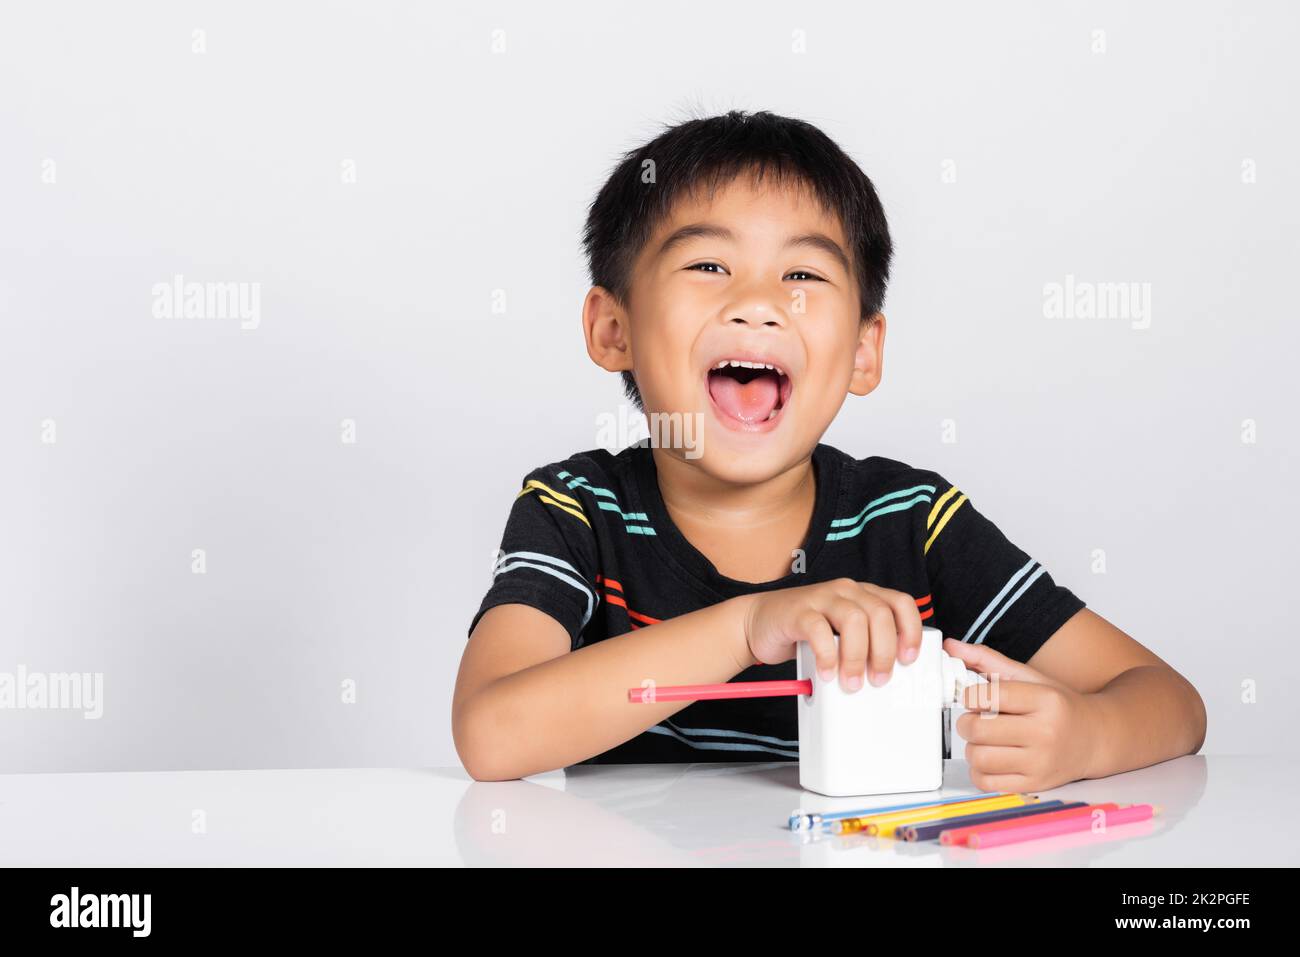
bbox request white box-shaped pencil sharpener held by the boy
[796,628,987,797]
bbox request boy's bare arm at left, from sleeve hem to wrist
[451,596,754,780]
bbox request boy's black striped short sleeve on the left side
[468,467,599,650]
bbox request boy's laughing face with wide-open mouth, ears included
[584,177,884,482]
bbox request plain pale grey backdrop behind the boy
[0,3,1300,771]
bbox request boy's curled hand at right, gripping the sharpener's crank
[944,638,1100,792]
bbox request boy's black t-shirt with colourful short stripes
[469,442,1084,765]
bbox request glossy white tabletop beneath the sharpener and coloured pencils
[0,754,1300,867]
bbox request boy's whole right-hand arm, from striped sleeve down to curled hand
[923,473,1205,791]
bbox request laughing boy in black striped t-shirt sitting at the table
[452,111,1205,792]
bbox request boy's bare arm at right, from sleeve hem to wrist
[1027,609,1206,778]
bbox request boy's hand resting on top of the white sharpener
[745,579,920,692]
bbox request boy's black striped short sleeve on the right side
[924,476,1084,662]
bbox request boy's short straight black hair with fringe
[582,109,893,411]
